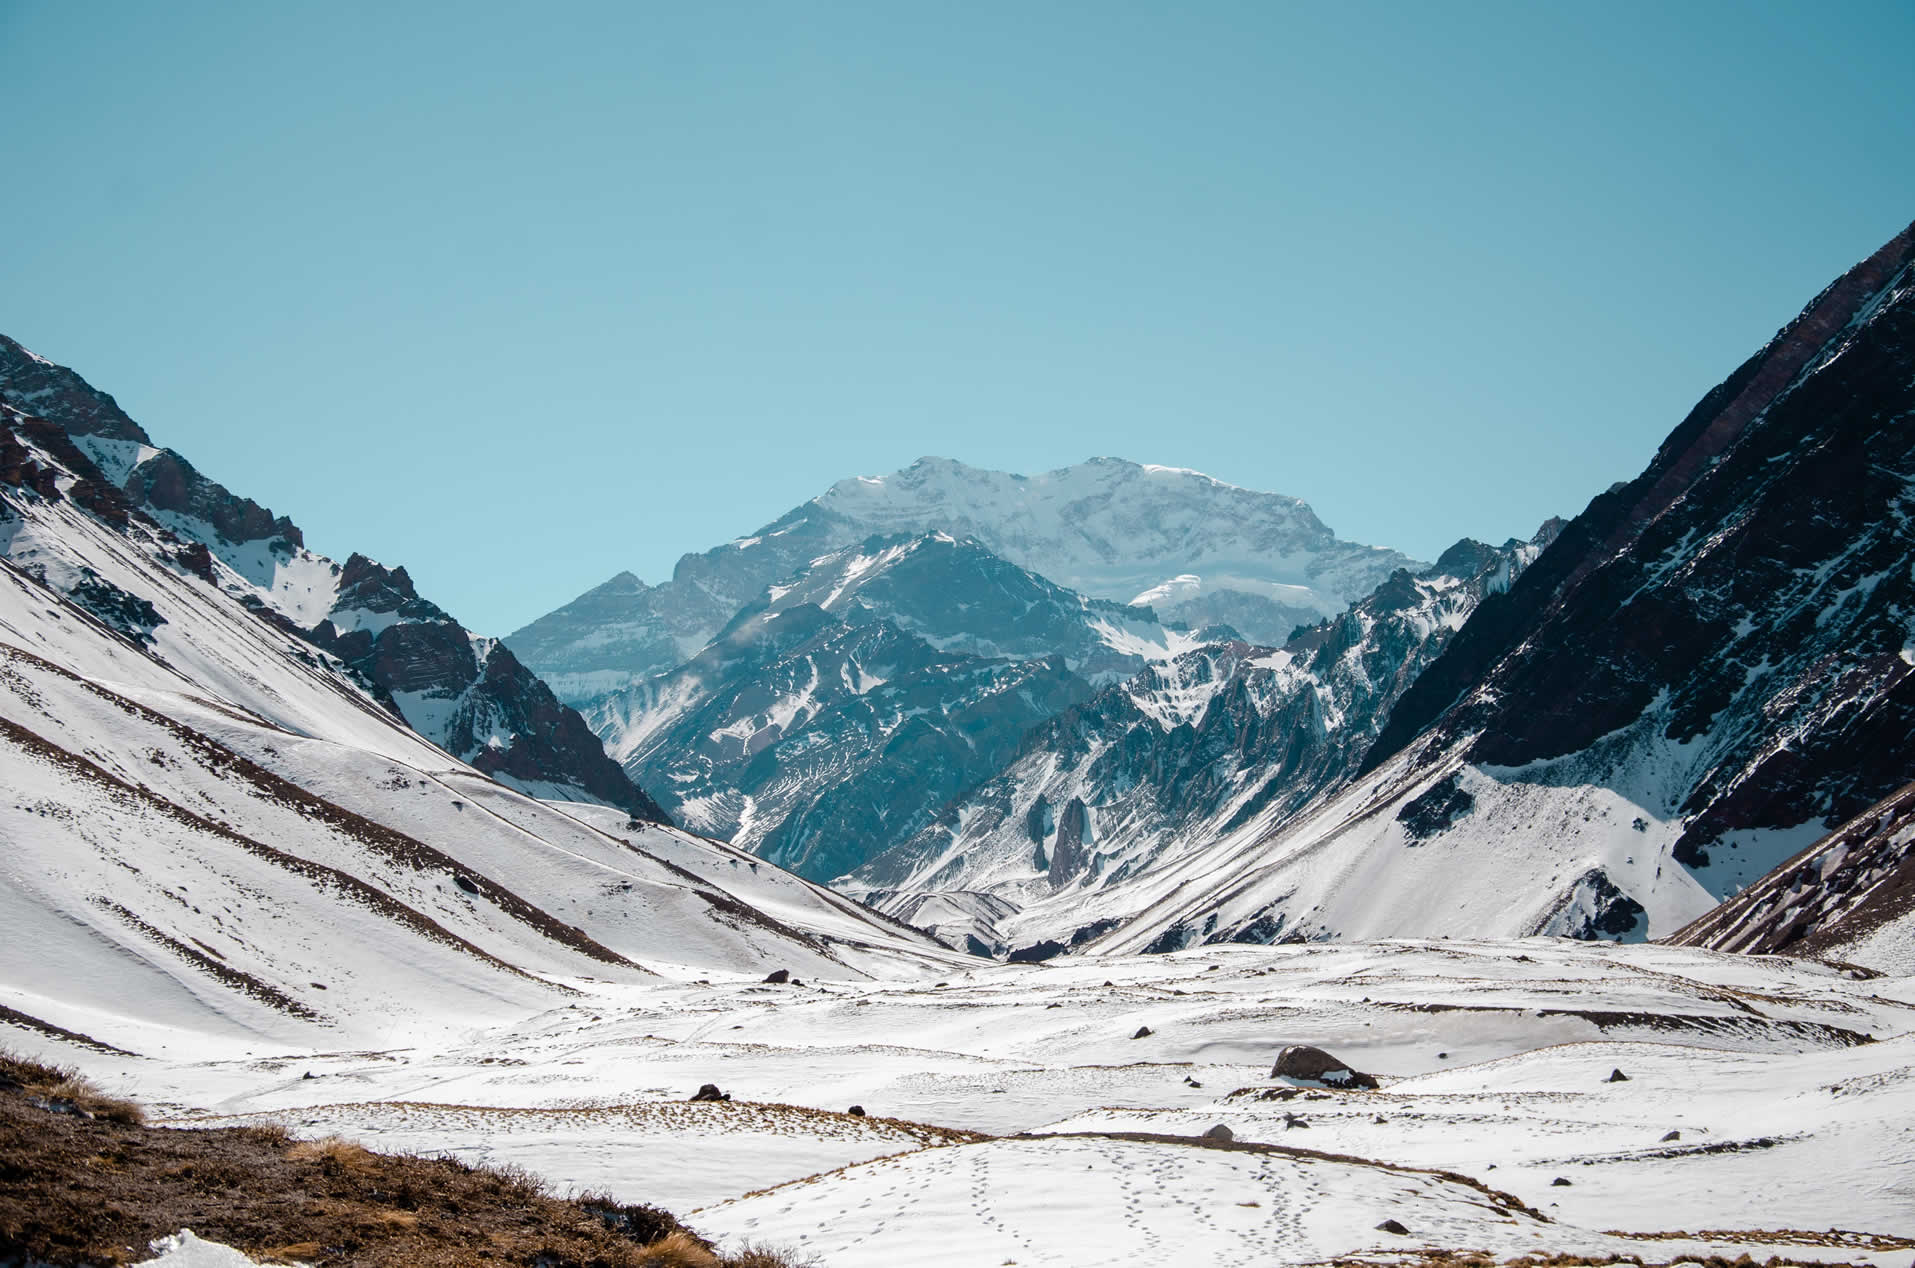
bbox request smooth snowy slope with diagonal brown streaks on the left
[0,406,948,1052]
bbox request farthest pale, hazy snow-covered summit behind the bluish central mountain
[506,458,1423,703]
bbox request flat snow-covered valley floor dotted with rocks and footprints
[22,939,1915,1268]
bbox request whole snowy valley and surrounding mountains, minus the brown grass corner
[0,213,1915,1268]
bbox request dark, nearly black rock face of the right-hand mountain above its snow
[1365,221,1915,884]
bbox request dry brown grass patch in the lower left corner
[0,1053,802,1268]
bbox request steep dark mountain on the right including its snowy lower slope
[1101,226,1915,969]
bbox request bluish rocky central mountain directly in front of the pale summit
[586,534,1225,879]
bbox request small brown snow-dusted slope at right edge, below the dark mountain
[1670,783,1915,967]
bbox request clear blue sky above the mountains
[0,0,1915,634]
